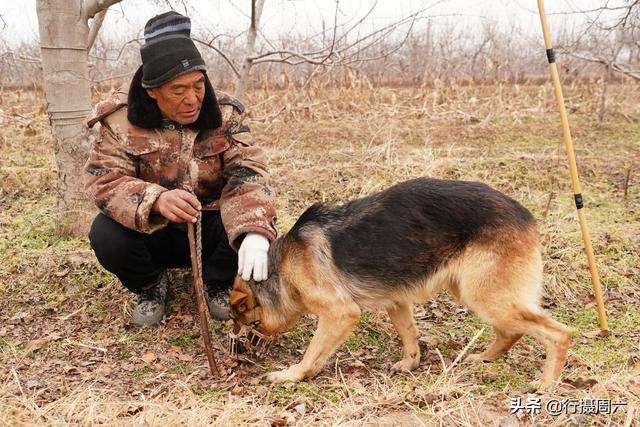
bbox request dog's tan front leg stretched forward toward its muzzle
[267,303,360,383]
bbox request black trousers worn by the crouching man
[89,211,238,293]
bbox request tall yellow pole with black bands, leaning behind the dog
[538,0,609,331]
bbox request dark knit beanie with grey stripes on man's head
[140,11,207,89]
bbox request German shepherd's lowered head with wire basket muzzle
[229,276,274,357]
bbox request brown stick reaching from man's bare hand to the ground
[187,213,220,375]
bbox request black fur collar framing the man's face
[127,66,222,131]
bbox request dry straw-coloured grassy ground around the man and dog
[0,81,640,425]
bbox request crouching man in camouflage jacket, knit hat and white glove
[85,12,276,326]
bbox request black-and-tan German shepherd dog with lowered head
[229,178,571,385]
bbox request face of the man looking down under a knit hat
[147,71,204,125]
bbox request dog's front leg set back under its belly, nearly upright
[387,302,420,372]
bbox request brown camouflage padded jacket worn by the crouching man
[85,89,277,250]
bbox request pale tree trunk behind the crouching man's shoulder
[36,0,119,236]
